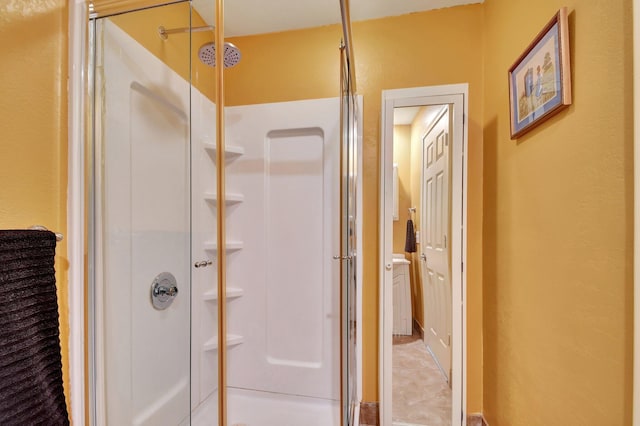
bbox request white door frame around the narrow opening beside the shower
[378,83,469,426]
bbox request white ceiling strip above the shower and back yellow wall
[193,0,484,37]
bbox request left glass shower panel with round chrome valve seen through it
[90,2,192,426]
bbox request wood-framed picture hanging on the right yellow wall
[509,7,571,139]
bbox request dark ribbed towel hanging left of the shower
[0,230,69,426]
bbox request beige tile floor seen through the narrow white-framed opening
[392,334,451,426]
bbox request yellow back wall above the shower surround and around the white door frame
[225,5,483,412]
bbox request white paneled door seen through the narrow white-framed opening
[420,105,451,381]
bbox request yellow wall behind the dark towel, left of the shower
[0,0,69,420]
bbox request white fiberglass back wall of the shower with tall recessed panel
[225,98,340,426]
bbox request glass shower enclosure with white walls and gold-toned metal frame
[87,0,359,426]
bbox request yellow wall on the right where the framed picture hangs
[483,0,633,426]
